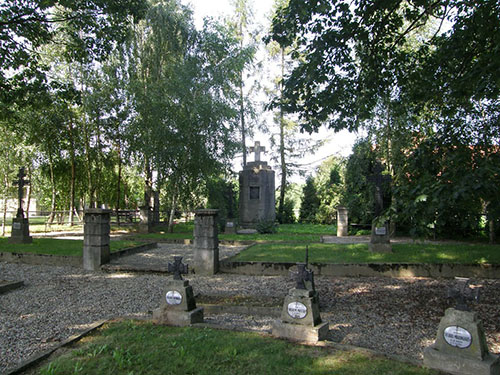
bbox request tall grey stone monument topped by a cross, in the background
[239,142,276,229]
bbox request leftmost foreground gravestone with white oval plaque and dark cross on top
[153,256,203,326]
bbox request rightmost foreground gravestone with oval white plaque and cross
[424,278,500,375]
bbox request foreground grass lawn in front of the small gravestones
[40,321,437,375]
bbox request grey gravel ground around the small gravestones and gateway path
[0,245,500,372]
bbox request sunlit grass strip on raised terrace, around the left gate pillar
[0,237,143,257]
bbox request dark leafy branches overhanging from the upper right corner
[271,0,500,139]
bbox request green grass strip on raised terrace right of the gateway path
[234,243,500,264]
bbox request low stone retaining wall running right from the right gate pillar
[220,259,500,279]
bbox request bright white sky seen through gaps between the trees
[181,0,357,186]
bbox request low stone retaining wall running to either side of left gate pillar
[0,242,157,268]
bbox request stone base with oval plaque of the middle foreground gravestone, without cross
[272,289,329,342]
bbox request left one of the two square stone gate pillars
[83,208,111,271]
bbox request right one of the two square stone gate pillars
[194,209,219,275]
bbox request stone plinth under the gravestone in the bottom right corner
[424,346,500,375]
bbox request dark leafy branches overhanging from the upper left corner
[0,0,145,116]
